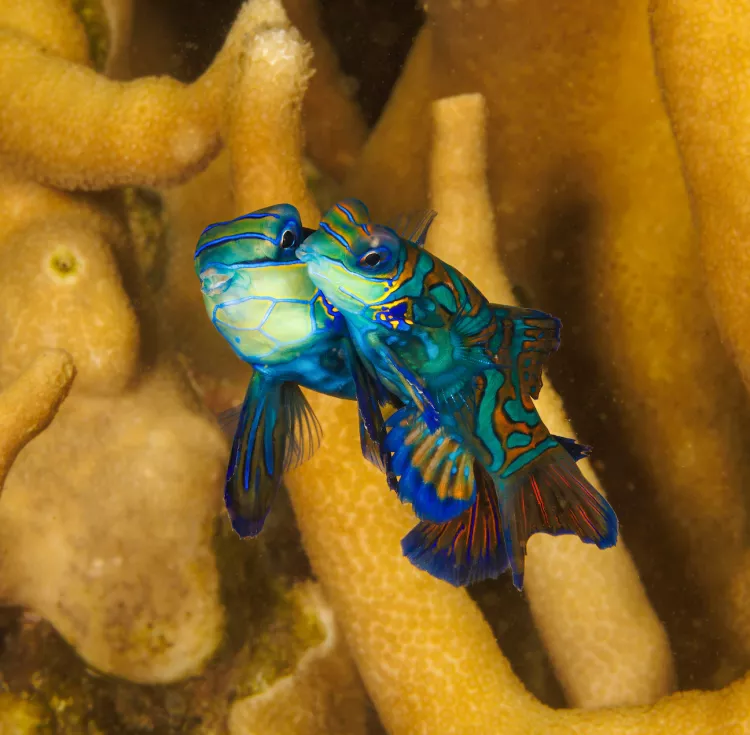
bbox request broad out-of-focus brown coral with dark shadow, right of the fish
[350,0,750,683]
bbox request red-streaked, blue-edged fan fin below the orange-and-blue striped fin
[401,466,508,587]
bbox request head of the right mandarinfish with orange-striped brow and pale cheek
[297,199,409,314]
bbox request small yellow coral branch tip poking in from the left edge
[0,350,75,489]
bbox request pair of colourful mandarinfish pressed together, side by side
[195,199,617,589]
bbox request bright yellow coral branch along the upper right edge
[651,0,750,388]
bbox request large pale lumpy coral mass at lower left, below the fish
[0,367,226,681]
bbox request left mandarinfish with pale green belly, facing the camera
[194,204,458,537]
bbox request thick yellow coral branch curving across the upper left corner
[0,0,284,189]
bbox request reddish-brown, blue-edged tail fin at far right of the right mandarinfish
[498,446,618,589]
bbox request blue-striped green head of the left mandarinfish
[194,204,310,317]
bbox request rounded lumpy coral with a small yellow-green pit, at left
[0,217,139,393]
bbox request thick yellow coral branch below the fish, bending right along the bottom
[287,394,750,735]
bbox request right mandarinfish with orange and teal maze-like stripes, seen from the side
[297,199,618,589]
